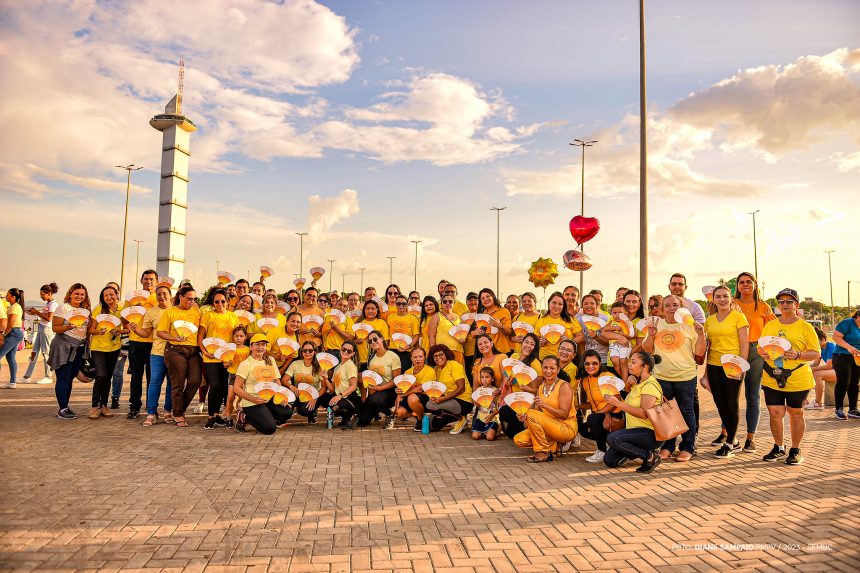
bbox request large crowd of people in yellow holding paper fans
[0,270,860,472]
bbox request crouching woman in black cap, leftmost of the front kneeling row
[233,334,293,436]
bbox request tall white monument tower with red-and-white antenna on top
[149,59,197,284]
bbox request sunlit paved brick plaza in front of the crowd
[0,358,860,572]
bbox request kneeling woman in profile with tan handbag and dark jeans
[603,350,663,473]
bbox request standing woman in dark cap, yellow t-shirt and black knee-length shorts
[757,288,821,465]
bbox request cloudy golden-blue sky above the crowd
[0,0,860,305]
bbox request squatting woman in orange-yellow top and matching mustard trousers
[514,356,577,463]
